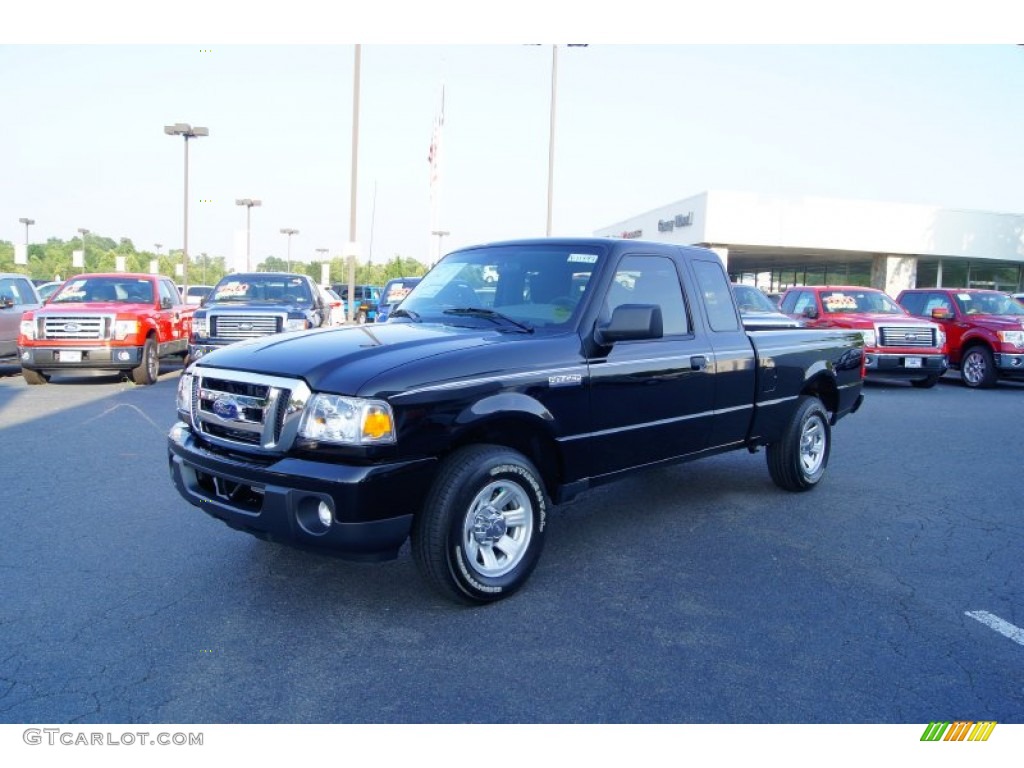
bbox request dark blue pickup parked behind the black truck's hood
[188,272,331,360]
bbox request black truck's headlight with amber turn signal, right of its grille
[299,394,394,445]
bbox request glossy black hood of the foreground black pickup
[194,323,500,394]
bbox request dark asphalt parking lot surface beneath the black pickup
[0,365,1024,724]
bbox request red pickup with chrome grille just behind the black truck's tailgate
[779,286,948,389]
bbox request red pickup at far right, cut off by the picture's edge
[896,288,1024,388]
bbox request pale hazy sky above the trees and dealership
[0,0,1024,272]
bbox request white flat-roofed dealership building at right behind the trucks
[595,190,1024,296]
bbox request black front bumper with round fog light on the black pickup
[167,422,436,560]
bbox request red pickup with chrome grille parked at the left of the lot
[17,272,195,384]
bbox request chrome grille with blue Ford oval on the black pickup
[189,367,310,454]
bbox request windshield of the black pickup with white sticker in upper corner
[392,243,604,331]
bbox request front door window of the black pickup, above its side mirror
[605,256,690,336]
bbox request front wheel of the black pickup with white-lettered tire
[413,445,548,604]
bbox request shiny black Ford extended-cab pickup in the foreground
[168,239,863,603]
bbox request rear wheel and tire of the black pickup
[767,396,831,492]
